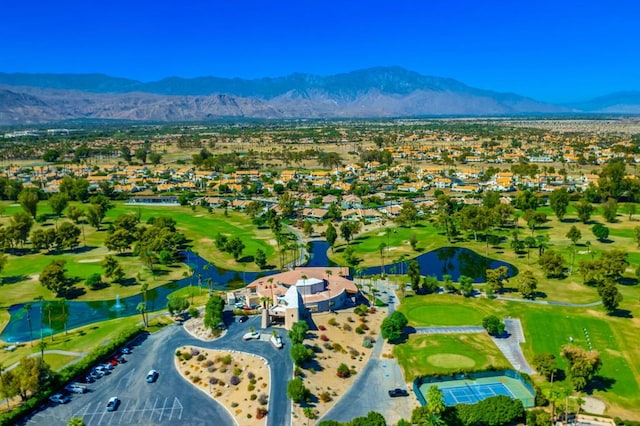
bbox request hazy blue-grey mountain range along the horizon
[0,67,640,125]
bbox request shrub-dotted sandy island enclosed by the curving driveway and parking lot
[175,346,270,426]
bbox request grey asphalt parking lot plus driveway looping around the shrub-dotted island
[24,317,293,426]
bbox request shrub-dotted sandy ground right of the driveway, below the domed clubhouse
[293,309,386,424]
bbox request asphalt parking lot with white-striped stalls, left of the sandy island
[23,326,233,426]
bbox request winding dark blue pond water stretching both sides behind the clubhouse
[0,245,518,343]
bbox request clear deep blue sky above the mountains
[0,0,640,102]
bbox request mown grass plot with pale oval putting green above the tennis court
[393,334,509,381]
